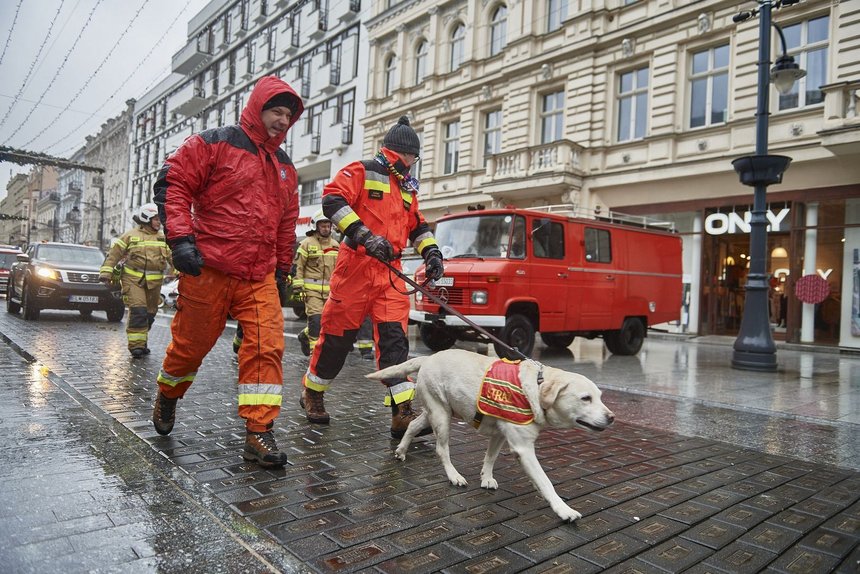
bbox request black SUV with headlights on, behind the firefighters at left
[6,243,125,322]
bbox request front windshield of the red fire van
[435,214,525,259]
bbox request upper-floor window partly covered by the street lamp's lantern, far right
[774,16,830,110]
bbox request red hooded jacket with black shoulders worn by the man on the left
[154,76,304,281]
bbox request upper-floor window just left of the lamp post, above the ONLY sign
[690,44,729,128]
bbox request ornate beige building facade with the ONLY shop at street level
[363,0,860,347]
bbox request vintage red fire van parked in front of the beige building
[409,206,682,358]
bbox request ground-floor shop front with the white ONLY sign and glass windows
[619,191,860,348]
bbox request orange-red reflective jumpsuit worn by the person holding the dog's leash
[302,148,436,405]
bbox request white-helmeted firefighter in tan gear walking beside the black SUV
[99,203,173,358]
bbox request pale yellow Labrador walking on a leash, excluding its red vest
[367,349,615,521]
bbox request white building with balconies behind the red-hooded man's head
[127,0,369,235]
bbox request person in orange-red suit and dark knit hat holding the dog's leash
[300,116,444,438]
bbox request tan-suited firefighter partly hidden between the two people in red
[293,210,340,357]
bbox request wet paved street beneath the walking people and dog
[0,310,860,574]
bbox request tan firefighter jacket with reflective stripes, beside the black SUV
[99,225,173,287]
